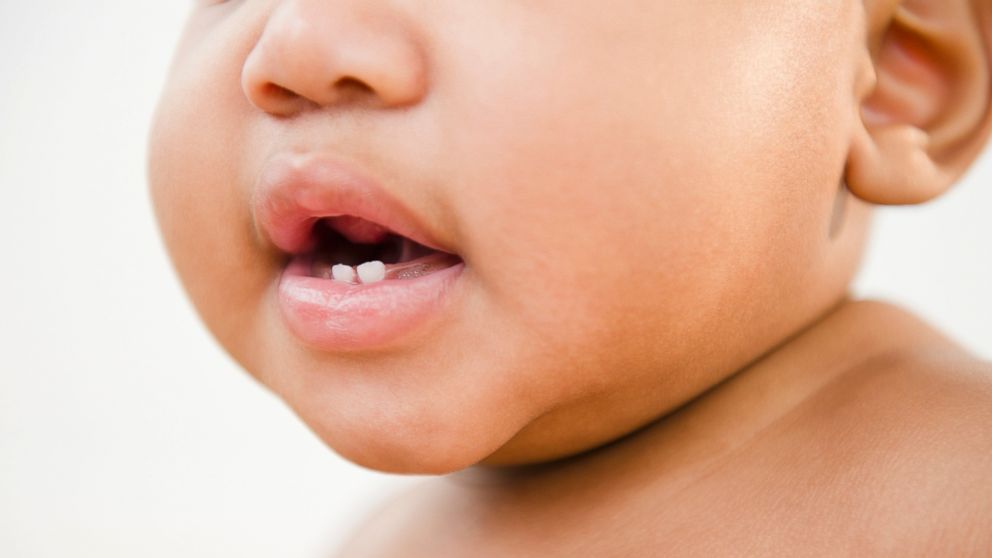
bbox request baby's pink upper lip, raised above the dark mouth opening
[252,153,450,254]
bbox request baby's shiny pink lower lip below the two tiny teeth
[278,257,465,352]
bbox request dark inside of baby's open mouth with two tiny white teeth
[303,215,462,284]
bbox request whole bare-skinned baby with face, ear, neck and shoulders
[149,0,992,557]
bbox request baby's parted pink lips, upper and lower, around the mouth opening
[253,153,465,352]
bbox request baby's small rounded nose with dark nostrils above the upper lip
[241,0,428,116]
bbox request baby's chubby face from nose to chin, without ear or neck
[150,0,861,472]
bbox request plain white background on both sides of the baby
[0,0,992,558]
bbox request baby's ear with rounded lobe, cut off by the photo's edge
[846,0,992,205]
